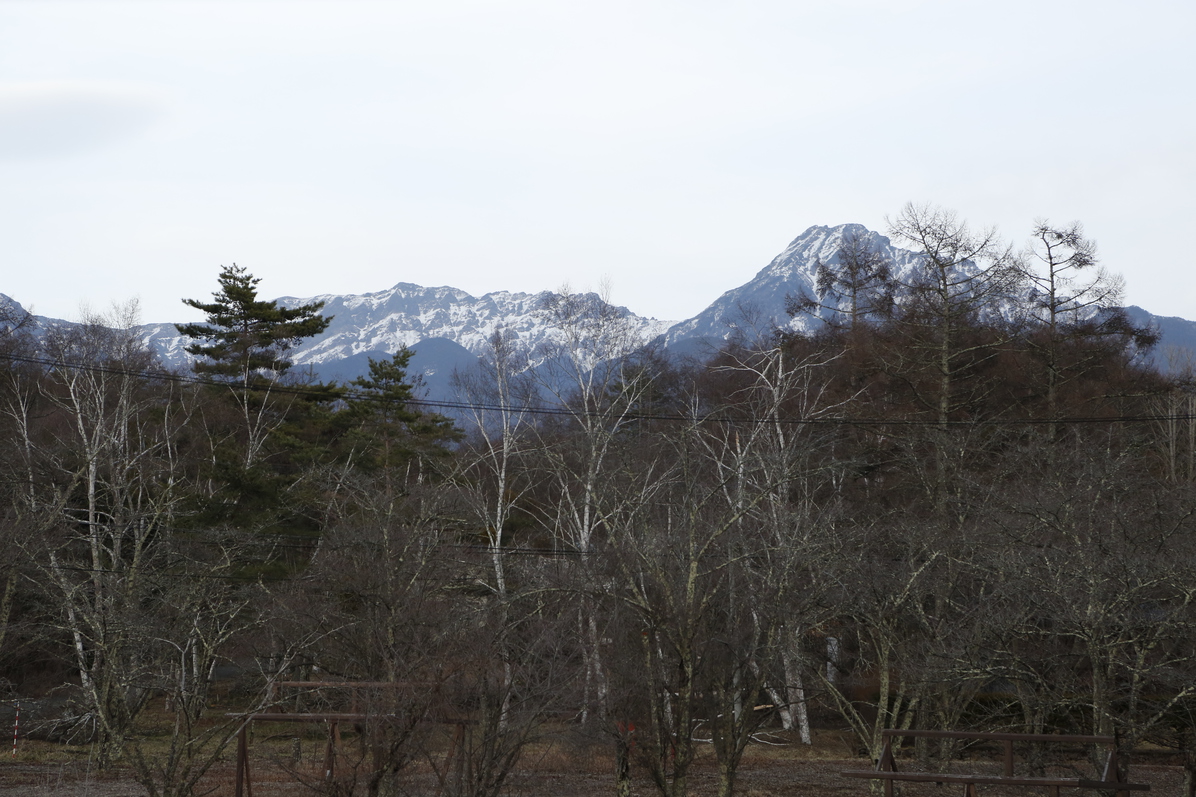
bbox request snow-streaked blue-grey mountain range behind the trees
[10,224,1196,397]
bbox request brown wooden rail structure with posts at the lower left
[228,681,471,797]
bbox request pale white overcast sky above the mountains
[0,0,1196,321]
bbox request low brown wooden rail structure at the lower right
[840,730,1151,797]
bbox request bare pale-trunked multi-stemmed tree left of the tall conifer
[35,306,189,766]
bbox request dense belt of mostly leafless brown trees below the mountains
[0,207,1196,797]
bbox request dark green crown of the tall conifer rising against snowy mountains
[177,263,332,388]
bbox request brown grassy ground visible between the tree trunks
[0,731,1183,797]
